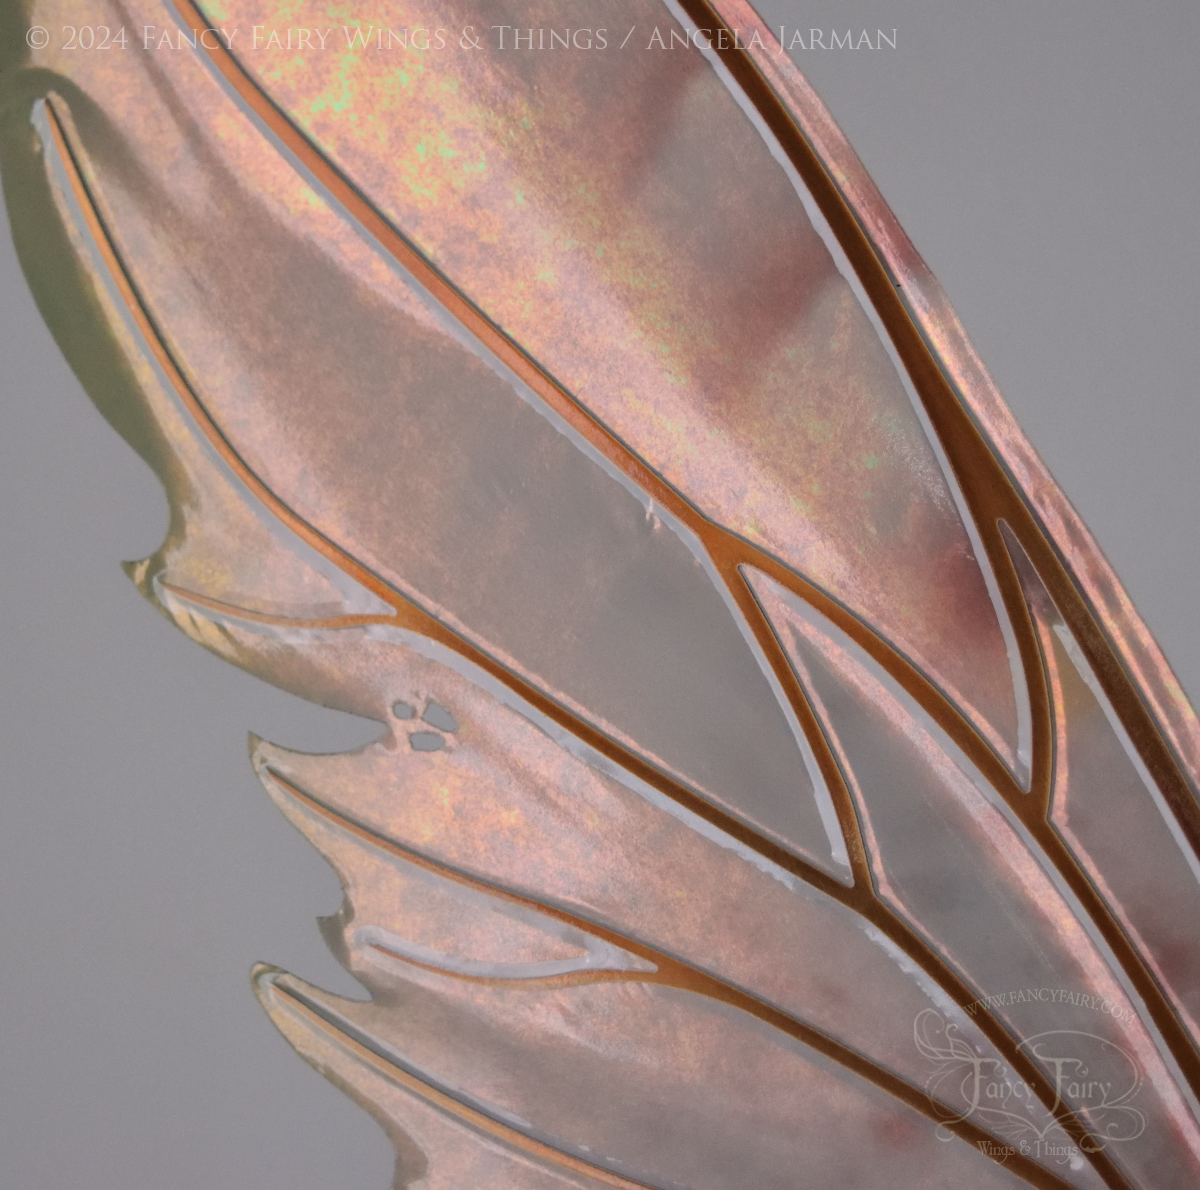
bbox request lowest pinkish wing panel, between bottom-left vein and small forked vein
[258,976,1020,1190]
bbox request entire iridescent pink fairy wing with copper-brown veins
[4,0,1200,1190]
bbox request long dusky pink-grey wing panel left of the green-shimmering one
[30,0,846,877]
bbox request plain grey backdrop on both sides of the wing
[0,0,1200,1190]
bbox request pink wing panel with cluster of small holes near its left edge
[246,621,989,1113]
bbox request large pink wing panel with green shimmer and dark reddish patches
[189,0,1024,770]
